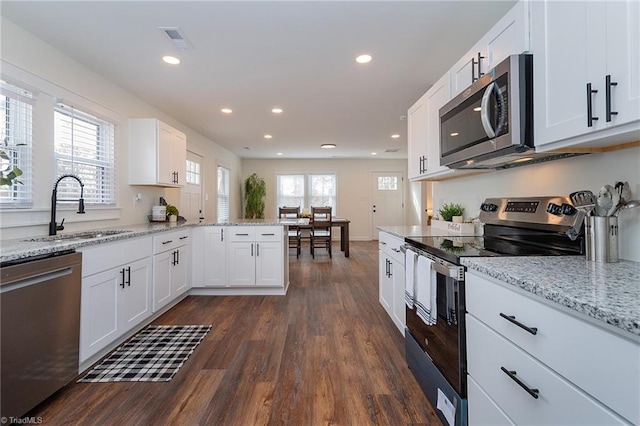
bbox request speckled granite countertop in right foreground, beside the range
[462,256,640,337]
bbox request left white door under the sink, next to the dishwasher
[80,268,124,362]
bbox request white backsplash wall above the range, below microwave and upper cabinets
[433,146,640,261]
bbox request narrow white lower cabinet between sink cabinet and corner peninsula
[153,230,191,312]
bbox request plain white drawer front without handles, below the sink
[79,237,152,277]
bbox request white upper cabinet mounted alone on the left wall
[129,118,187,187]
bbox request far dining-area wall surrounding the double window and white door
[242,159,419,240]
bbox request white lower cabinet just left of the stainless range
[378,232,406,336]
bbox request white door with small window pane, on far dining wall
[371,172,404,239]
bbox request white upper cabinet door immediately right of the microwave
[531,1,605,146]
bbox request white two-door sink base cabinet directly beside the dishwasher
[80,237,152,363]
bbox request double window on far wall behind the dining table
[276,173,337,214]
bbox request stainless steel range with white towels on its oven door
[405,196,585,426]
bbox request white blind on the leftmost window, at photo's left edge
[0,81,34,208]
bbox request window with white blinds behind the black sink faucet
[54,104,116,205]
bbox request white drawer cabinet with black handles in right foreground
[466,271,640,425]
